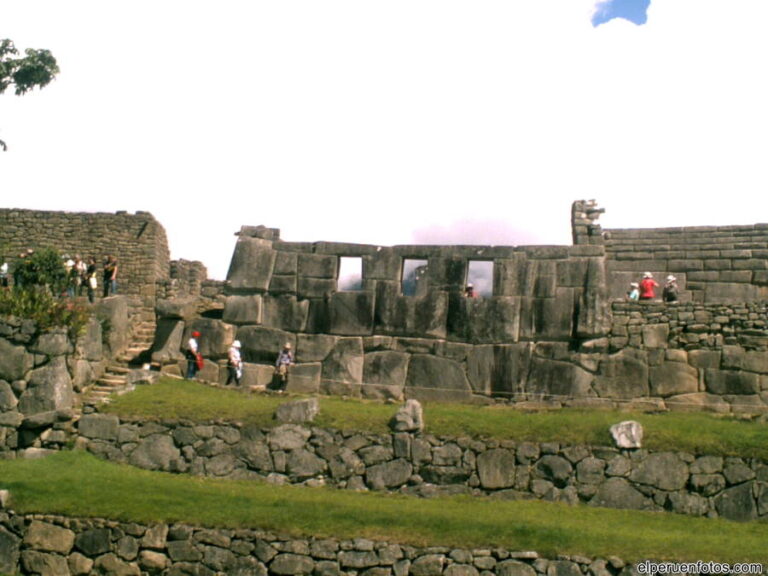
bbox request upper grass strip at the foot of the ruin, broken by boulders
[104,379,768,460]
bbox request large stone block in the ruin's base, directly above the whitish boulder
[594,349,650,399]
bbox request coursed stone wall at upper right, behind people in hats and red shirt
[605,224,768,303]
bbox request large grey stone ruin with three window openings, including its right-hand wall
[148,201,768,412]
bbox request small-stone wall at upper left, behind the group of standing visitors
[0,208,170,319]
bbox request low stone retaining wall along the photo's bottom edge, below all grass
[0,512,632,576]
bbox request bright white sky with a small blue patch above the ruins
[0,0,768,279]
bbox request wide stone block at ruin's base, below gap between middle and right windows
[405,354,472,402]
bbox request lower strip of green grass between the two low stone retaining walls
[0,452,768,562]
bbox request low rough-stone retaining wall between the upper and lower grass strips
[78,414,768,520]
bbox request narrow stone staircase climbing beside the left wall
[81,321,156,412]
